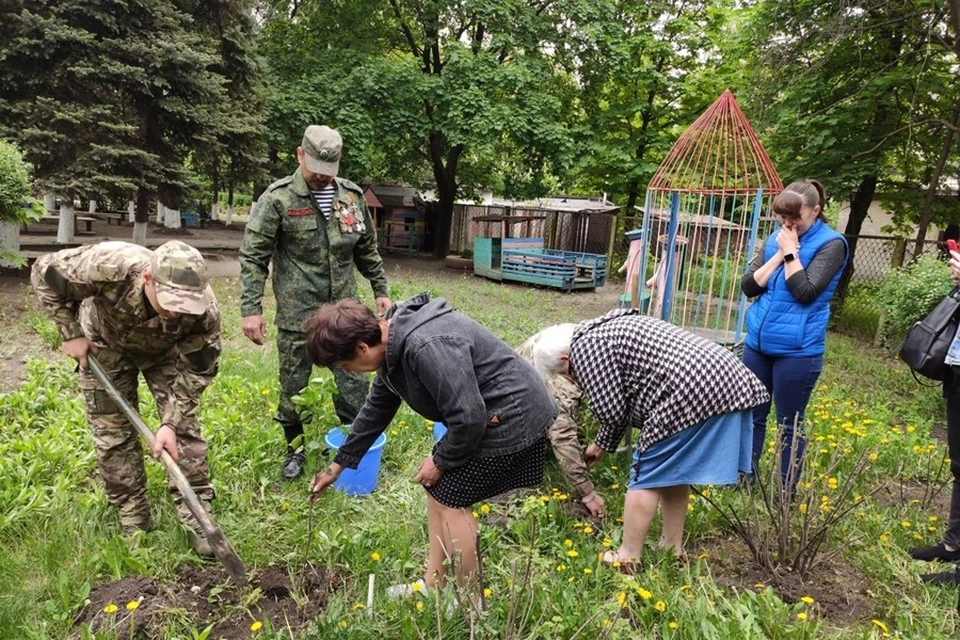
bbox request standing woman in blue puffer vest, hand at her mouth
[740,180,848,487]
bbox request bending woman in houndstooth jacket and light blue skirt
[533,309,769,570]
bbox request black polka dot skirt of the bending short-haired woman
[425,436,547,509]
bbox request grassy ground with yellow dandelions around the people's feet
[0,260,957,639]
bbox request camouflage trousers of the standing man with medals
[274,329,370,443]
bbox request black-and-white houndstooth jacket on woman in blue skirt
[570,309,770,452]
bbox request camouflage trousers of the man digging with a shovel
[80,348,214,530]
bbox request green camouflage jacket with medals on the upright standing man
[240,169,387,331]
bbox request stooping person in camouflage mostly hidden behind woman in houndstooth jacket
[517,333,604,517]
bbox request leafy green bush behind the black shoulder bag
[876,255,953,345]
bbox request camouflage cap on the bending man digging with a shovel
[150,240,210,316]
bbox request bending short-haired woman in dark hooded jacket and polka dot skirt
[307,293,557,597]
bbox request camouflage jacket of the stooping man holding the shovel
[30,242,220,429]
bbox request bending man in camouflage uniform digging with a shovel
[31,240,220,556]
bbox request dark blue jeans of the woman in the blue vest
[743,347,824,484]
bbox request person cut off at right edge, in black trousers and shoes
[910,246,960,585]
